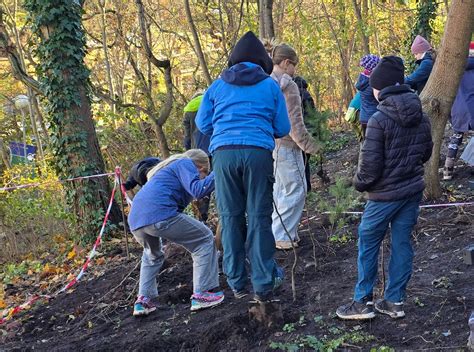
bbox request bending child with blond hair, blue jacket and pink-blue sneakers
[128,149,224,316]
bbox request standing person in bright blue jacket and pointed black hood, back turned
[196,32,290,301]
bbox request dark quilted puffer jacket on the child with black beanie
[353,85,433,201]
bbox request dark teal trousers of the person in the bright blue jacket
[213,148,276,293]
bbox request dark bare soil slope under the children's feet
[0,134,474,351]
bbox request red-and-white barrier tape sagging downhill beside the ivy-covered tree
[0,167,122,325]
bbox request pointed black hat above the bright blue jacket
[228,31,273,74]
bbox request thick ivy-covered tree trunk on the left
[25,0,122,238]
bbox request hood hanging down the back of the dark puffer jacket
[377,84,423,127]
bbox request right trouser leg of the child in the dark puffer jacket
[384,193,422,302]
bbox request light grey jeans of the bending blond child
[133,214,219,298]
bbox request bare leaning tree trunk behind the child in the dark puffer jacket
[420,0,474,199]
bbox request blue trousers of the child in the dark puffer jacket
[354,192,422,302]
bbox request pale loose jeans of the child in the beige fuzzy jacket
[272,146,306,241]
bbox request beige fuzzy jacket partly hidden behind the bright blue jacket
[271,70,320,154]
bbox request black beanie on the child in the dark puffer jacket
[369,56,405,90]
